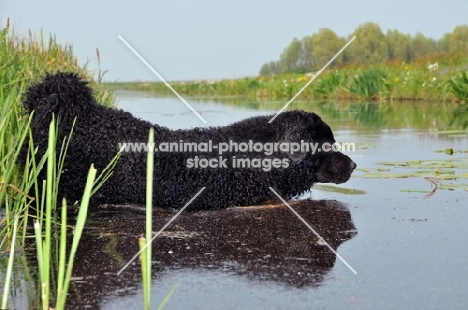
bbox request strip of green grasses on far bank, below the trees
[107,54,468,102]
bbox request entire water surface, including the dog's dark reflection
[11,93,468,309]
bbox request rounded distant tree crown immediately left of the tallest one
[311,28,346,69]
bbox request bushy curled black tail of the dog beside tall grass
[23,72,95,119]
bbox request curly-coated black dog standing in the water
[24,72,356,210]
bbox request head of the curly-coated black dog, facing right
[275,111,356,184]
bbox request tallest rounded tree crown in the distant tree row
[346,23,389,64]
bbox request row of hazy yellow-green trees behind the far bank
[260,22,468,75]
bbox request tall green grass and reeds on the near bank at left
[0,18,118,309]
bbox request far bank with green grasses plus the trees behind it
[110,23,468,102]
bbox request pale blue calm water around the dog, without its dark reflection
[107,93,468,309]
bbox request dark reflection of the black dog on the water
[46,200,356,305]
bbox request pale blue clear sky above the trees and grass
[0,0,468,81]
